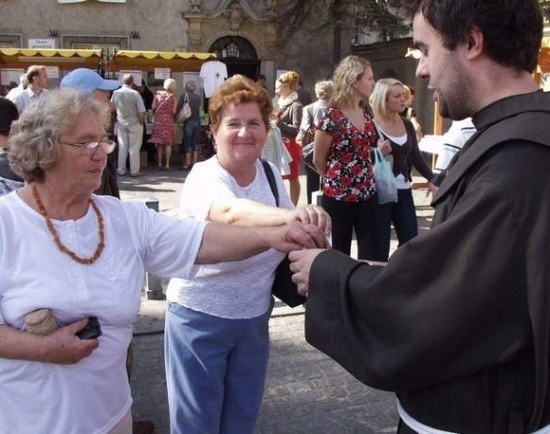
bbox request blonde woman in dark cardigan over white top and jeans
[370,78,436,251]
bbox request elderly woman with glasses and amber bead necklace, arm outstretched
[0,90,324,434]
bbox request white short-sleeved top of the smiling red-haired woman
[166,156,294,319]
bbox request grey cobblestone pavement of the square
[119,164,433,434]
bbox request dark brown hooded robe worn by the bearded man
[306,92,550,433]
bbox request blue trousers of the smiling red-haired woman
[164,303,273,434]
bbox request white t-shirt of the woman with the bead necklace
[0,192,205,434]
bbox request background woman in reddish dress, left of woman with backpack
[150,78,178,170]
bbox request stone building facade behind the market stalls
[0,0,350,95]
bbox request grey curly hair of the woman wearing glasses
[8,89,110,182]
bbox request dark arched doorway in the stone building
[208,36,260,80]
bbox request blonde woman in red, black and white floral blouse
[313,55,389,261]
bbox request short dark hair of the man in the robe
[402,0,543,72]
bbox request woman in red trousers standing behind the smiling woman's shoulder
[275,71,303,205]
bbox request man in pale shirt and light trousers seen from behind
[111,74,145,176]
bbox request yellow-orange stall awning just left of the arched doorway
[112,50,216,72]
